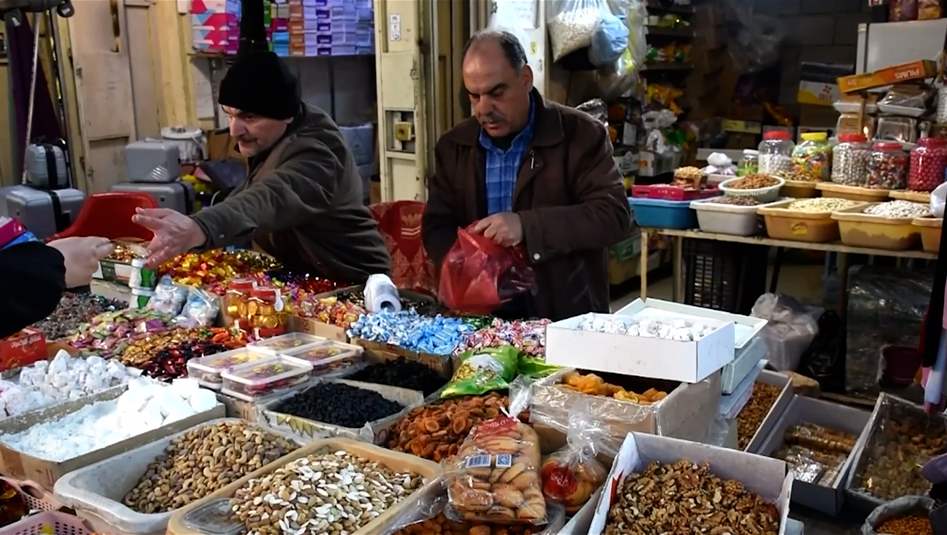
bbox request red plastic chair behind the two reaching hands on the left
[52,192,158,240]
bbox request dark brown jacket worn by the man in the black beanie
[193,102,390,283]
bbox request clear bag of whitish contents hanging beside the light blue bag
[546,0,611,61]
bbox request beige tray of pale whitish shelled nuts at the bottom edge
[168,438,441,535]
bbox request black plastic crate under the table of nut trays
[683,239,767,314]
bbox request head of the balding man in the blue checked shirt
[463,30,533,138]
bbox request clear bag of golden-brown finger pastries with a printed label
[444,386,547,525]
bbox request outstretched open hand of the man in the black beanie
[132,208,207,268]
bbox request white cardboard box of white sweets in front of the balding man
[546,312,734,383]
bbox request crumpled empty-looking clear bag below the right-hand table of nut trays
[750,293,820,371]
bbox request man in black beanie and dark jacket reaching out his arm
[134,52,390,283]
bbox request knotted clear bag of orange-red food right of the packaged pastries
[540,403,608,514]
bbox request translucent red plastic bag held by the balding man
[438,221,534,314]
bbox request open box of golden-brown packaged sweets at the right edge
[845,394,947,511]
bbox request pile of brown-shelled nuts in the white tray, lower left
[123,422,297,514]
